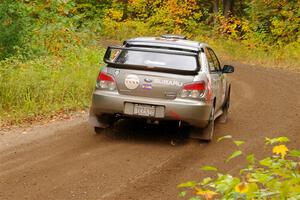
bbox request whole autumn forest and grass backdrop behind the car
[0,0,300,127]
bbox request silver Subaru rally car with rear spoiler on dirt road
[89,35,234,141]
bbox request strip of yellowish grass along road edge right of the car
[205,38,300,72]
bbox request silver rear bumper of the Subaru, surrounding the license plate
[90,90,211,127]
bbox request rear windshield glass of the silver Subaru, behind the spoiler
[115,50,197,71]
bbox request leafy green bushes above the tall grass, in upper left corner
[0,0,106,60]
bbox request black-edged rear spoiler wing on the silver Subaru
[103,46,200,75]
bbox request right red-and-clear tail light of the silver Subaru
[179,81,206,99]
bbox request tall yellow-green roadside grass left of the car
[0,46,104,127]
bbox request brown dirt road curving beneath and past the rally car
[0,63,300,200]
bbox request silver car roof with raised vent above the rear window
[124,35,208,52]
